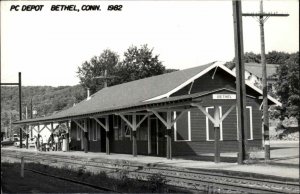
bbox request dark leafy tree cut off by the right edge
[276,52,300,124]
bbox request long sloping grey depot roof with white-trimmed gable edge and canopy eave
[14,62,280,124]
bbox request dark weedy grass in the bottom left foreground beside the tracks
[1,162,173,193]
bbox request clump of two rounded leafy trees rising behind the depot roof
[77,45,166,93]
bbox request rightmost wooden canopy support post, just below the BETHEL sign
[214,106,220,163]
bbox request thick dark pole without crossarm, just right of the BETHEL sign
[232,0,247,164]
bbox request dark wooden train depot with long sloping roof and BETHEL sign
[14,62,280,159]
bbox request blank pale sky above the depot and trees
[1,0,299,86]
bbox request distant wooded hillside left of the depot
[1,85,86,131]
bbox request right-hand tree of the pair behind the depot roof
[114,45,166,84]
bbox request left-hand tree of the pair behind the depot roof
[77,49,119,94]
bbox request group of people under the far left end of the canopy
[35,134,65,151]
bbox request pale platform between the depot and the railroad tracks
[1,142,299,179]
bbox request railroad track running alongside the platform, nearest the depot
[1,151,299,193]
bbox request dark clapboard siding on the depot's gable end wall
[172,70,262,156]
